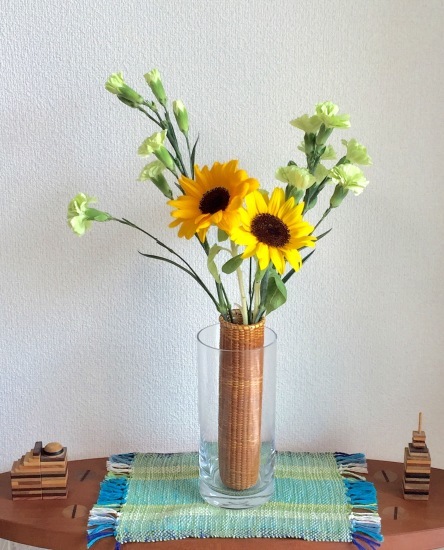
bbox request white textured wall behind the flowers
[0,0,444,496]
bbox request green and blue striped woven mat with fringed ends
[88,452,382,550]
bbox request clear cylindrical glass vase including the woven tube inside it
[197,321,276,508]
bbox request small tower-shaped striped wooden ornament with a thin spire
[402,413,432,500]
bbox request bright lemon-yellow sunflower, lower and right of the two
[230,187,316,275]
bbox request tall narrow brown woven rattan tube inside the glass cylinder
[219,315,265,491]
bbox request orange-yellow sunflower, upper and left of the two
[168,160,259,242]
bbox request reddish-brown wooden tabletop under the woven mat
[0,458,444,550]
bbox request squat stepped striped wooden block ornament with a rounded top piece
[11,441,68,500]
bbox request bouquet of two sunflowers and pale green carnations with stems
[68,69,371,325]
